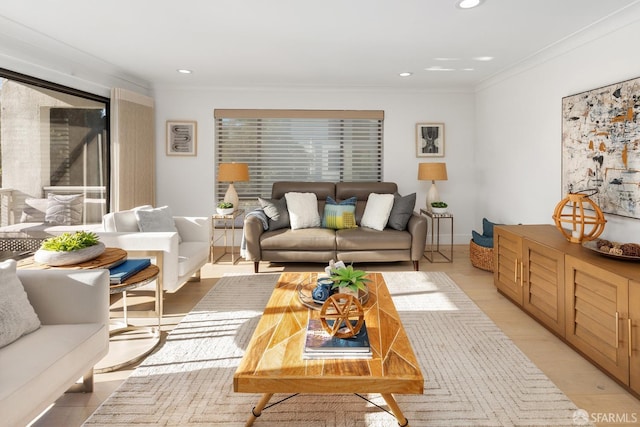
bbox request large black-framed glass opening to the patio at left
[0,69,109,226]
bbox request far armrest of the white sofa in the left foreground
[18,269,109,325]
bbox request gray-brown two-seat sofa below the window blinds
[244,181,427,273]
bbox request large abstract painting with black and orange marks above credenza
[562,78,640,218]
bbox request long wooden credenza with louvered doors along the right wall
[494,225,640,396]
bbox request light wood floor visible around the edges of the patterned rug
[33,245,640,427]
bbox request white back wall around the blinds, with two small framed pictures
[154,87,479,243]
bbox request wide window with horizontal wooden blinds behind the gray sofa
[214,110,384,208]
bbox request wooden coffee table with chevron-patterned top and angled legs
[233,273,424,426]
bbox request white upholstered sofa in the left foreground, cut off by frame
[0,269,109,426]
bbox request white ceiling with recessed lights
[0,0,639,89]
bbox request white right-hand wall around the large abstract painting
[474,8,640,242]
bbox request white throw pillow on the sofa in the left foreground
[0,259,41,350]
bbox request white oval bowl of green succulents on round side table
[33,231,105,267]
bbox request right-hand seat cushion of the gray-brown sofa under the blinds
[336,227,411,252]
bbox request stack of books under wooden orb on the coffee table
[302,319,372,359]
